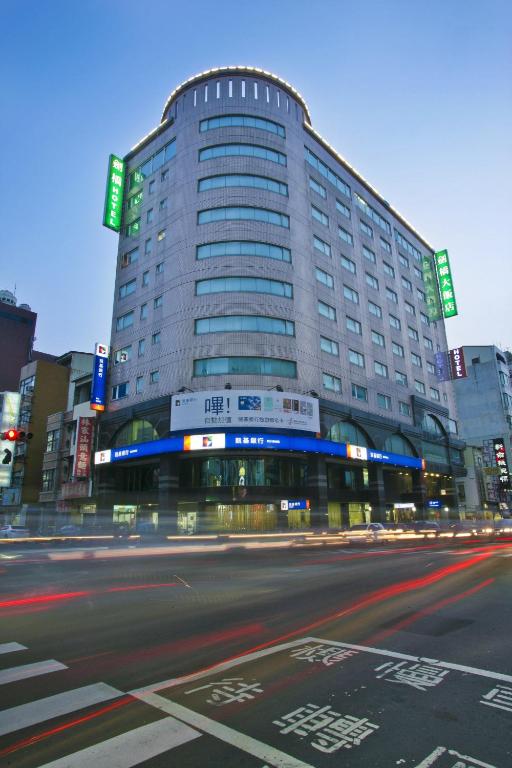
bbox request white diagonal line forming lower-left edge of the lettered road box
[134,693,313,768]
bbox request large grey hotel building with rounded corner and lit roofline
[94,67,464,532]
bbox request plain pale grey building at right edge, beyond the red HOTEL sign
[454,345,512,512]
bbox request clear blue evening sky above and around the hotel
[0,0,512,354]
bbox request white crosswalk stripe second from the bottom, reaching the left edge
[0,683,123,736]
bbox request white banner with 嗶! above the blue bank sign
[171,389,320,433]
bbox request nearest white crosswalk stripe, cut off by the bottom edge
[35,717,201,768]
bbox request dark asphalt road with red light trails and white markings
[0,543,512,768]
